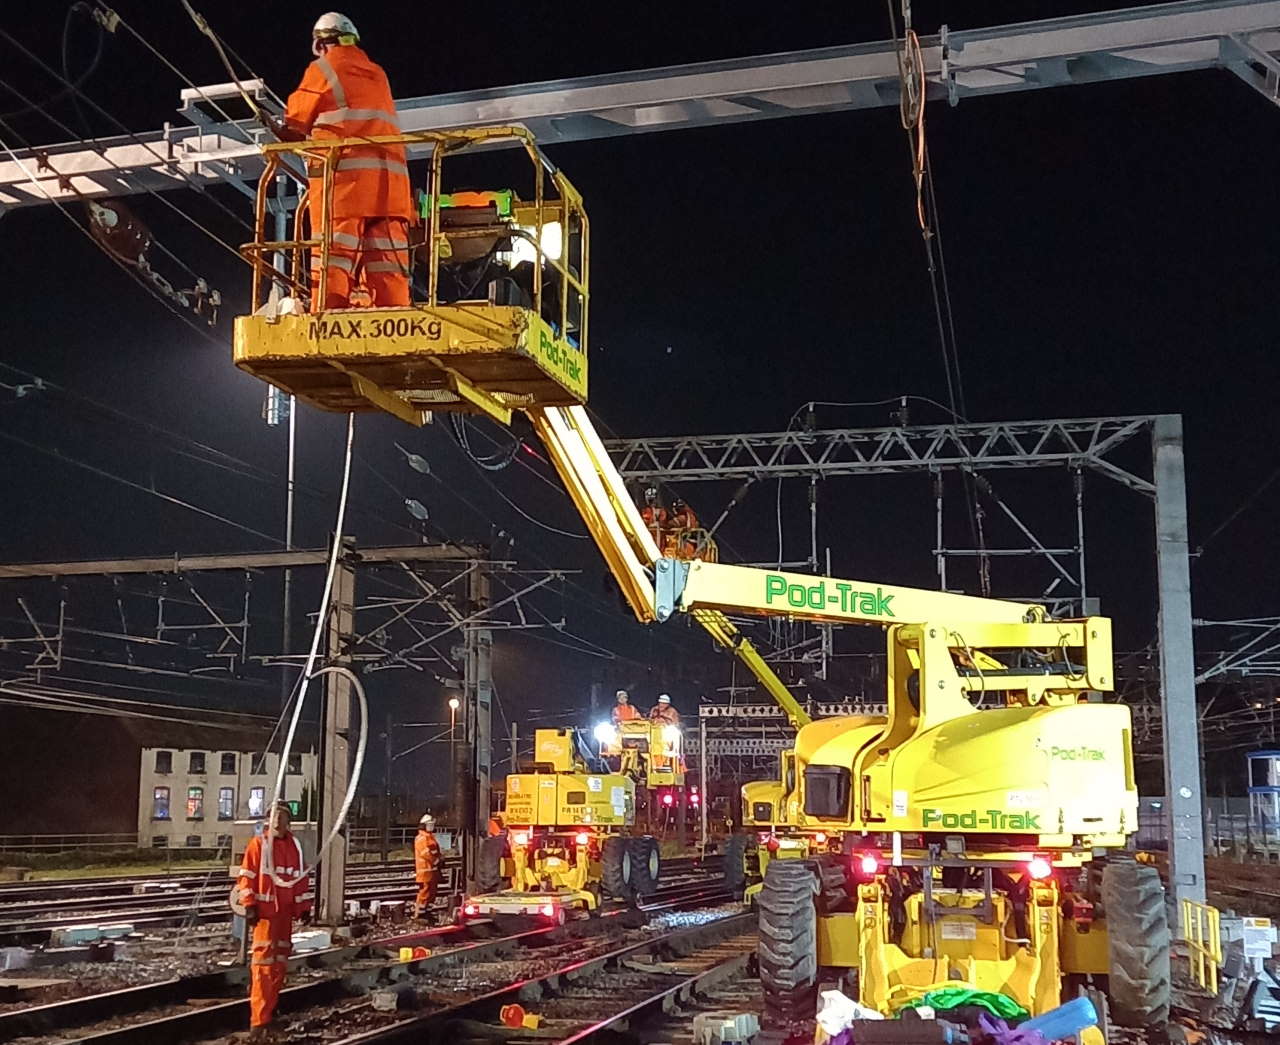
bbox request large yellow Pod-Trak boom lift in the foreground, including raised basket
[234,128,1169,1023]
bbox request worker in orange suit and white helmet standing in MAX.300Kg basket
[281,12,413,311]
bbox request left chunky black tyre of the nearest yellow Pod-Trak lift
[756,859,819,1030]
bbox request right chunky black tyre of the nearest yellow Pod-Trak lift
[1102,861,1171,1027]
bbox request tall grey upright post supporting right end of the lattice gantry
[1152,414,1204,909]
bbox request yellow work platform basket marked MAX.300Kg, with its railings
[234,128,588,424]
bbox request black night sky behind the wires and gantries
[0,0,1280,819]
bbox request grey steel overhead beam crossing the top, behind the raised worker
[0,0,1280,209]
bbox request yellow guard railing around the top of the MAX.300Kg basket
[241,127,590,351]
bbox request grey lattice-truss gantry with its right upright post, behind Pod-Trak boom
[605,414,1204,902]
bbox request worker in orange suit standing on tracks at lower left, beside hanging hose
[237,802,315,1037]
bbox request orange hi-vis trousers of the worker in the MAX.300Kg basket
[311,218,410,309]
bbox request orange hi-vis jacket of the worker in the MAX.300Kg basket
[284,44,413,218]
